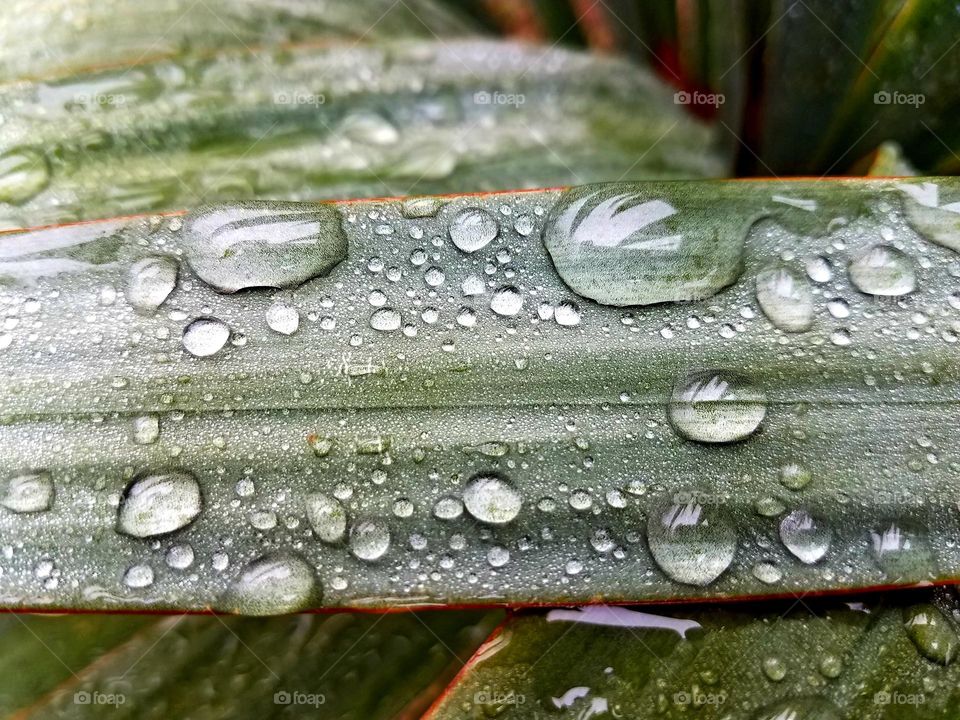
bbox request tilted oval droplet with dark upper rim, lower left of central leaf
[117,470,203,538]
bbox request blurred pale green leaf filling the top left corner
[0,0,474,82]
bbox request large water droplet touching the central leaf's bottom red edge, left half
[220,553,320,615]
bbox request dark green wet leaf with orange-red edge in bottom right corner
[426,591,960,720]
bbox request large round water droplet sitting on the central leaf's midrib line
[669,370,767,443]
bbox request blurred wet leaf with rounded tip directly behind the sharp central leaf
[0,40,724,228]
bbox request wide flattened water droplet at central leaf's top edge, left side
[185,202,347,293]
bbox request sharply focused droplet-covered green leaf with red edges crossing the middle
[0,178,960,614]
